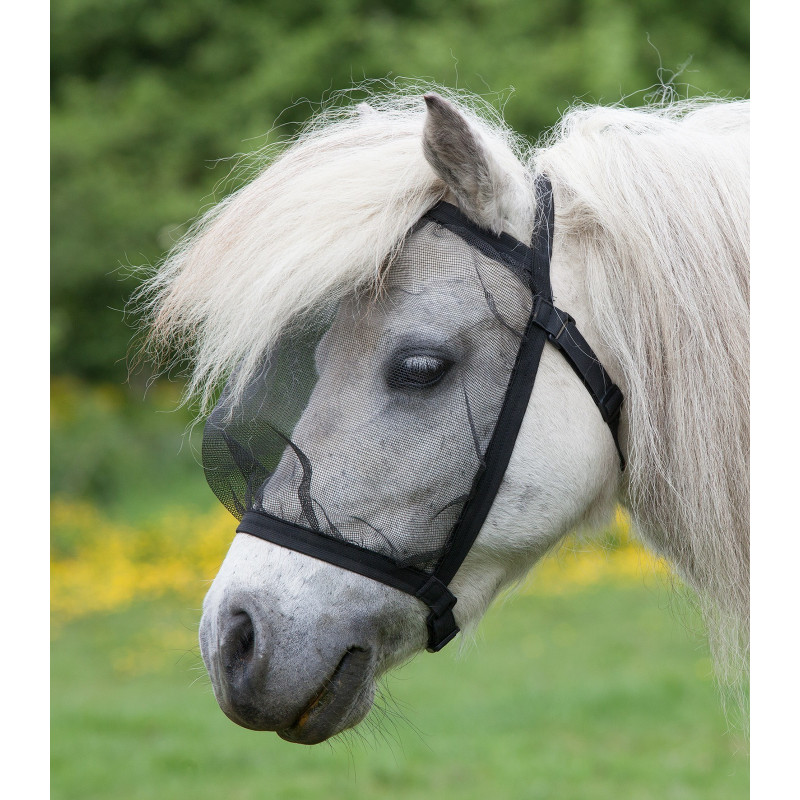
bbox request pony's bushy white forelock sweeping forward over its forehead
[133,87,528,414]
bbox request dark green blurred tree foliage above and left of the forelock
[51,0,749,380]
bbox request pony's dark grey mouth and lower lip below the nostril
[277,647,374,744]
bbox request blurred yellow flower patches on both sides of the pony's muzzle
[50,500,668,627]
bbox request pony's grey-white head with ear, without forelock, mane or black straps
[194,95,619,743]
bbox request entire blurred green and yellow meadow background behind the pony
[51,0,749,798]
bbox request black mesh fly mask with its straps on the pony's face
[203,178,624,651]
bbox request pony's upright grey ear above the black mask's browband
[422,93,509,233]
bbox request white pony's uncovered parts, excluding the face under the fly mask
[140,90,749,743]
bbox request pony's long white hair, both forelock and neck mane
[139,89,749,688]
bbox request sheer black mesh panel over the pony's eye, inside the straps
[203,218,533,573]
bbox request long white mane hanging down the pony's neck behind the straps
[533,100,750,686]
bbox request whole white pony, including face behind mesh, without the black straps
[139,87,749,744]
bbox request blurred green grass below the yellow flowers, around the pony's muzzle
[51,587,749,800]
